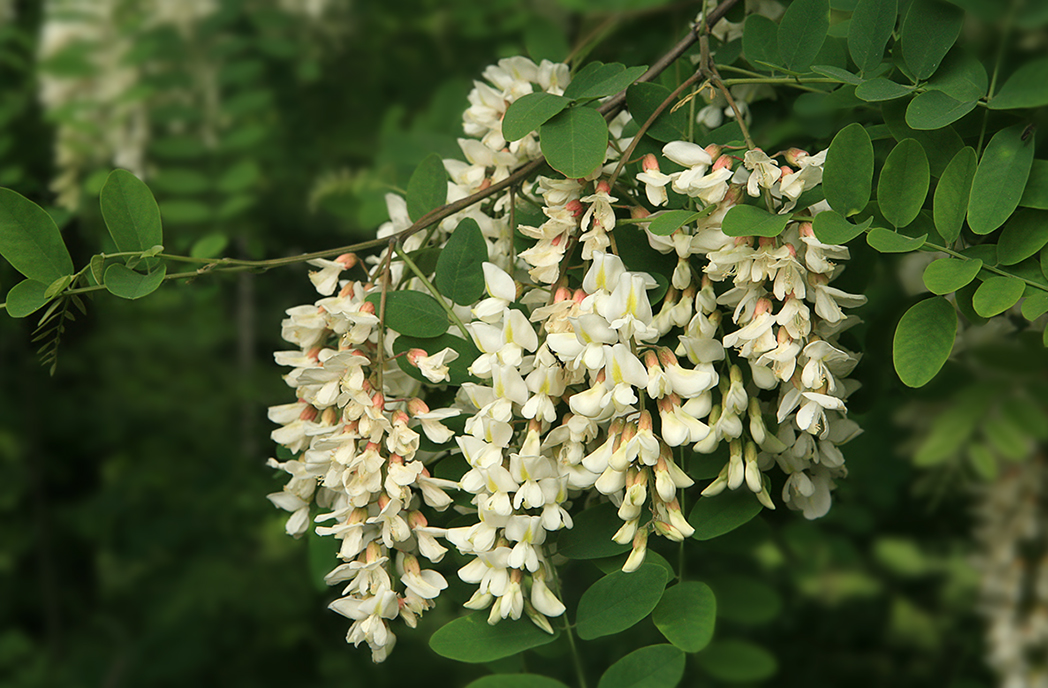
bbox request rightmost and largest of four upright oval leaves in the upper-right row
[968,124,1033,234]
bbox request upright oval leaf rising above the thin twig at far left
[100,170,163,251]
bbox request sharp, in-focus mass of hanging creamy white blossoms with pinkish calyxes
[270,58,865,661]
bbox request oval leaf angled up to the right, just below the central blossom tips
[575,563,669,640]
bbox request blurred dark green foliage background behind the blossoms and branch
[0,0,1048,688]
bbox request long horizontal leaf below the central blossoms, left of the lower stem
[430,611,560,664]
